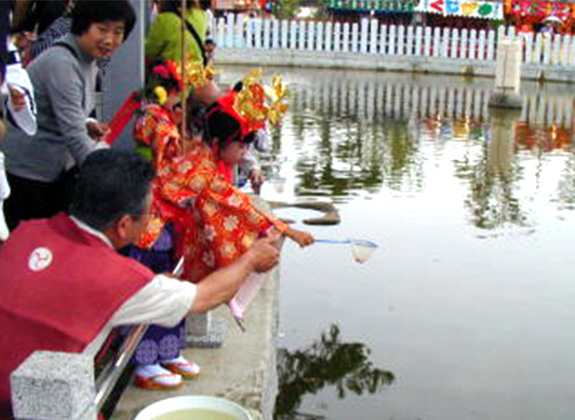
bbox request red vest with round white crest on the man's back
[0,214,154,419]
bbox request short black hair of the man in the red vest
[70,149,154,231]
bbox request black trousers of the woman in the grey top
[4,171,76,230]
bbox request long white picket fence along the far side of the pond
[214,14,575,68]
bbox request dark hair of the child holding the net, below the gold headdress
[203,102,255,148]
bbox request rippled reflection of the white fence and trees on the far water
[251,72,575,229]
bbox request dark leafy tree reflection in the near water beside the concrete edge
[275,324,395,420]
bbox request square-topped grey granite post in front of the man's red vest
[10,351,98,420]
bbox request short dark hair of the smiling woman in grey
[70,0,136,41]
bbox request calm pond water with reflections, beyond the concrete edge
[223,68,575,420]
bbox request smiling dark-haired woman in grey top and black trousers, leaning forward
[0,0,136,229]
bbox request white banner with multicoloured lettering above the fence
[415,0,503,20]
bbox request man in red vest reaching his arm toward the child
[0,150,279,419]
